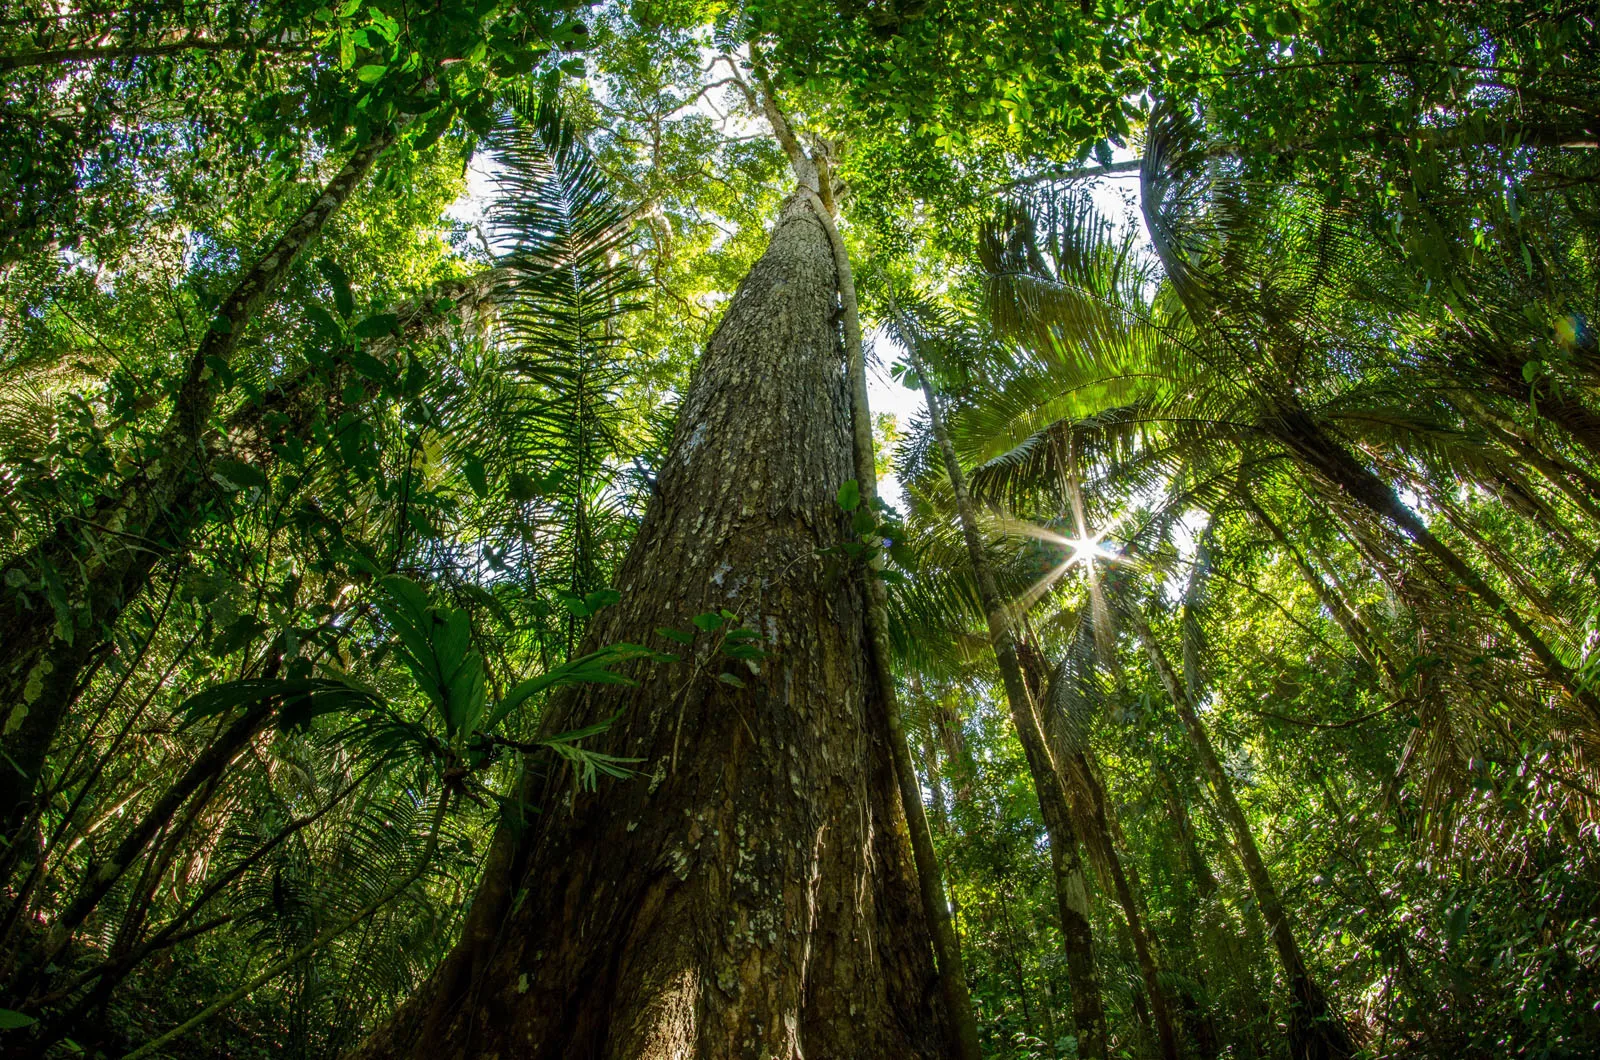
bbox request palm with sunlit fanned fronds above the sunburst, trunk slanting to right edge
[973,110,1600,739]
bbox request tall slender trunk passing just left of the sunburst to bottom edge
[907,344,1106,1057]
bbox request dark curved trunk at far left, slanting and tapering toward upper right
[0,130,398,841]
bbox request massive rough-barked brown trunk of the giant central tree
[357,200,947,1060]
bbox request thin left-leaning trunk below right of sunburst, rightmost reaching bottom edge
[1130,612,1354,1060]
